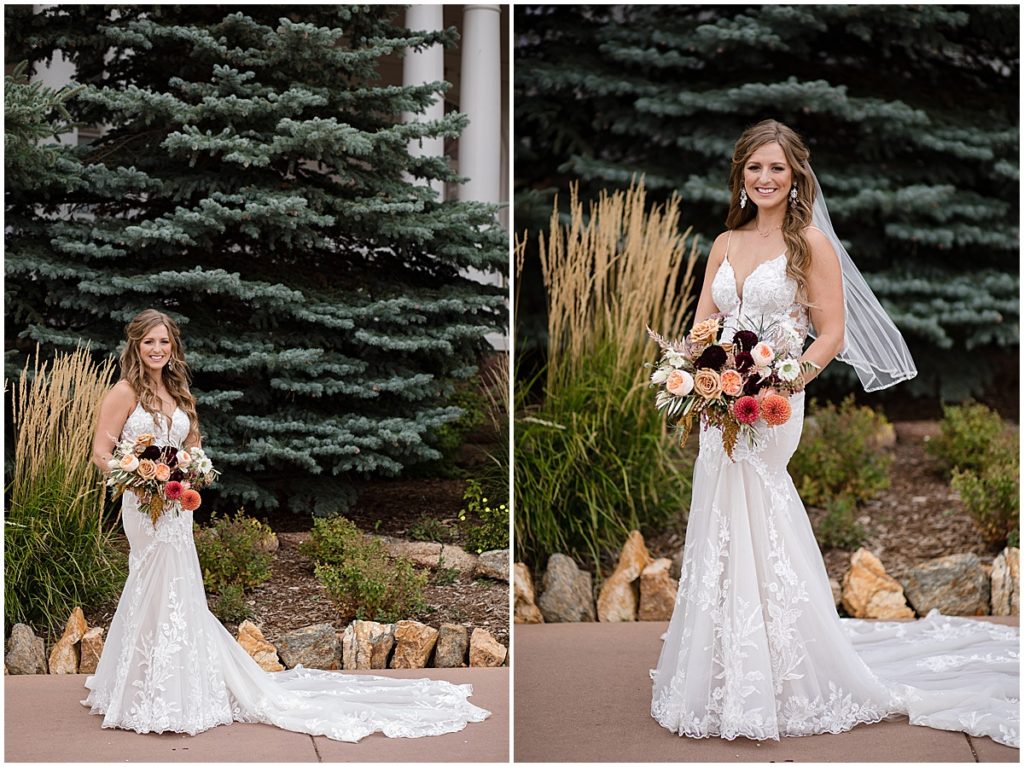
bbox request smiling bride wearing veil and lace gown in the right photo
[651,120,1020,748]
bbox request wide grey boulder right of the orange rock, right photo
[903,554,991,615]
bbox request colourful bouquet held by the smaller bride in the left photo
[106,434,220,524]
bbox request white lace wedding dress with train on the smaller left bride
[82,407,489,741]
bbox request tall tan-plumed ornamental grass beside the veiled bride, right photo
[514,182,697,568]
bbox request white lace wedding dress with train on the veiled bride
[651,248,1020,748]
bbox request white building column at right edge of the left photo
[459,5,502,209]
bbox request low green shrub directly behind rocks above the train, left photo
[315,541,427,623]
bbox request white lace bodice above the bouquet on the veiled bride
[711,253,809,341]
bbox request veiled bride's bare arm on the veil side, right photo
[800,228,846,384]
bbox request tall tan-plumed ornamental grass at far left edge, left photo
[4,348,126,635]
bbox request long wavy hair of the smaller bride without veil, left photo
[121,309,199,441]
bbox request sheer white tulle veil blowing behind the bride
[808,166,918,391]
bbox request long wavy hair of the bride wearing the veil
[725,120,814,303]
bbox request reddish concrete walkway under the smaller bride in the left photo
[4,668,509,763]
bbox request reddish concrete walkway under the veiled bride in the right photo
[513,617,1020,762]
